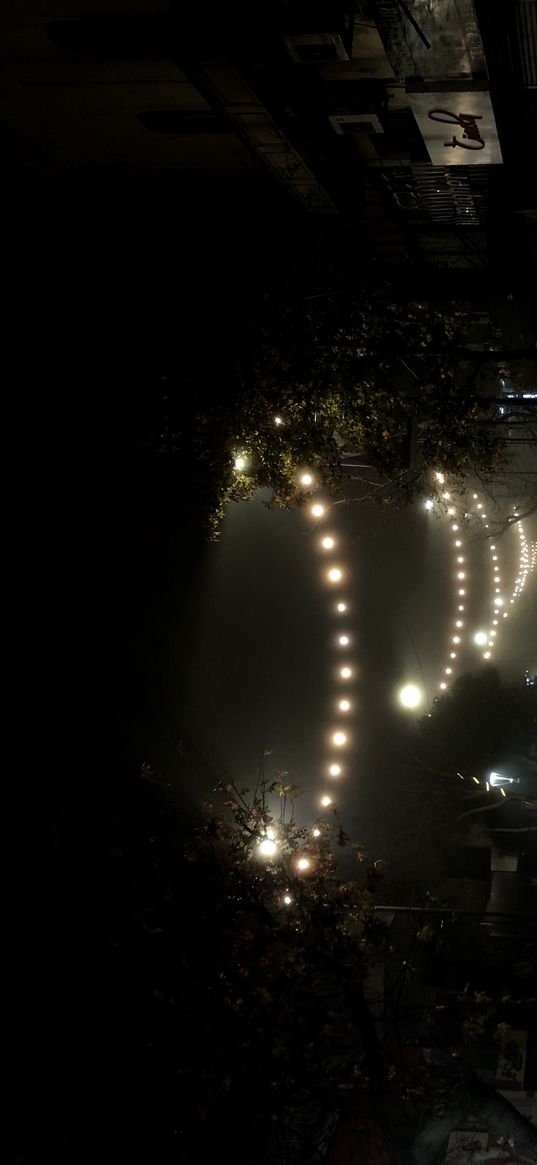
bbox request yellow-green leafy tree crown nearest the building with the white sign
[143,287,503,532]
